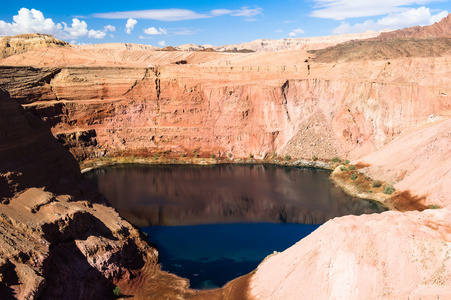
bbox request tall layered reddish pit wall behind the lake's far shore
[0,58,451,160]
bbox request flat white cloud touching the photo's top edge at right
[311,0,440,20]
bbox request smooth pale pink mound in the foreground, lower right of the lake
[251,210,451,299]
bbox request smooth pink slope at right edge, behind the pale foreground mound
[361,116,451,207]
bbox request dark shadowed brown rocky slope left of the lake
[0,90,192,299]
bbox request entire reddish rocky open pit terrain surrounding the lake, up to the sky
[0,16,451,299]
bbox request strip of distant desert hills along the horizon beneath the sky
[0,14,451,62]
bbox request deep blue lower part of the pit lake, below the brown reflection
[142,223,319,289]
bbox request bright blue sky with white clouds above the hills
[0,0,451,46]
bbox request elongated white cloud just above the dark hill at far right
[332,6,448,34]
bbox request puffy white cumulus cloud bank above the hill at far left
[0,8,106,39]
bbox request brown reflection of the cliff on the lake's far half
[86,165,384,227]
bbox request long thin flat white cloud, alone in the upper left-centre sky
[93,8,210,21]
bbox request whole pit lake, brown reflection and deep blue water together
[86,165,385,289]
